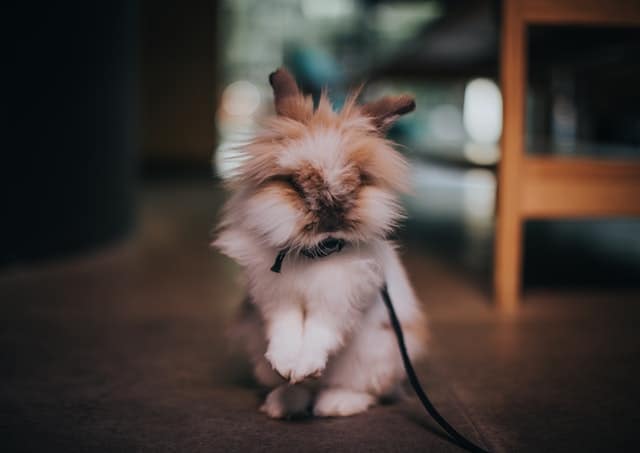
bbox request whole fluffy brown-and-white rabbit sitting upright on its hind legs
[214,68,426,418]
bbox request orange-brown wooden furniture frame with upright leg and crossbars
[494,0,640,311]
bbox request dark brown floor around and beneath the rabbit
[0,183,640,452]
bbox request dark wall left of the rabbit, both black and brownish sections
[0,0,218,266]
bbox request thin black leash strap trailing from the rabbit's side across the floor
[380,283,488,453]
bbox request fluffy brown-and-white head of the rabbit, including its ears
[224,68,415,249]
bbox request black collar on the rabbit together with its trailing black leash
[271,238,489,453]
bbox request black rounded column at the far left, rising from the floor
[5,0,138,265]
